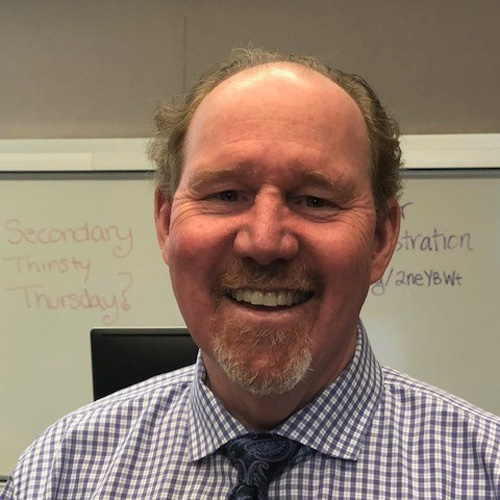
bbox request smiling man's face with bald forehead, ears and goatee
[155,65,399,396]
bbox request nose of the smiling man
[234,193,299,265]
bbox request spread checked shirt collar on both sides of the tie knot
[190,322,383,460]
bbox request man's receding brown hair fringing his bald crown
[149,49,401,218]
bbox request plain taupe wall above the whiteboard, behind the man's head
[0,0,500,139]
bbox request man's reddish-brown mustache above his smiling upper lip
[215,260,323,293]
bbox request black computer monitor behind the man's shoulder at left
[90,327,198,399]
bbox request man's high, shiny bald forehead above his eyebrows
[185,63,370,180]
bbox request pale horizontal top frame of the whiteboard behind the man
[0,134,500,172]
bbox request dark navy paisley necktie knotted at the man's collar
[221,433,307,500]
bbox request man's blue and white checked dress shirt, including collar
[0,326,500,500]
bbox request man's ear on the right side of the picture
[370,196,401,283]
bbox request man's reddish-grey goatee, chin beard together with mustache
[210,261,321,397]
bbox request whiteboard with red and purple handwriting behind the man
[0,170,500,475]
